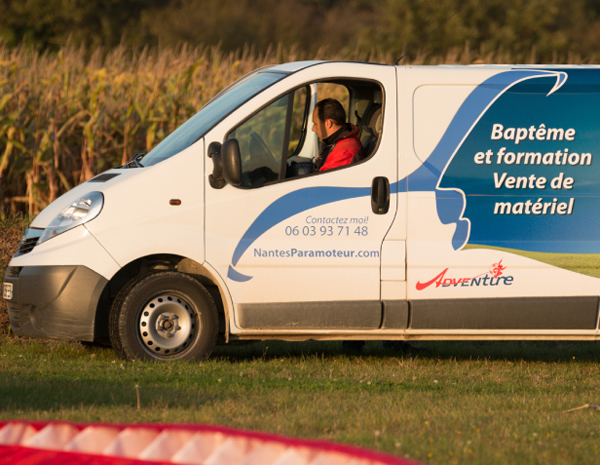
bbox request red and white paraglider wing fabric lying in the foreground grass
[0,421,422,465]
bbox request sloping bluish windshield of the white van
[142,70,287,166]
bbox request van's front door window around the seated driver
[226,79,384,188]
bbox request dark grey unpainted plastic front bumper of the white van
[4,265,108,341]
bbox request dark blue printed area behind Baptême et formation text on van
[438,69,600,253]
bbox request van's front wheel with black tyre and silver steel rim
[109,271,219,361]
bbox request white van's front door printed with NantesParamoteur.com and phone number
[206,63,397,333]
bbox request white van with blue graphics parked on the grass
[3,61,600,360]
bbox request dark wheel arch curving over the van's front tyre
[94,254,230,343]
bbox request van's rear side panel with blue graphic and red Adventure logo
[399,66,600,332]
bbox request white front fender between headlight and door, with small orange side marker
[87,143,204,266]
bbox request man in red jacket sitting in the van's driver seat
[312,98,362,171]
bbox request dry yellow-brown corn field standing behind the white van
[0,44,592,218]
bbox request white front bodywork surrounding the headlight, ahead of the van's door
[17,139,204,279]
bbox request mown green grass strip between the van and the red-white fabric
[0,338,600,464]
